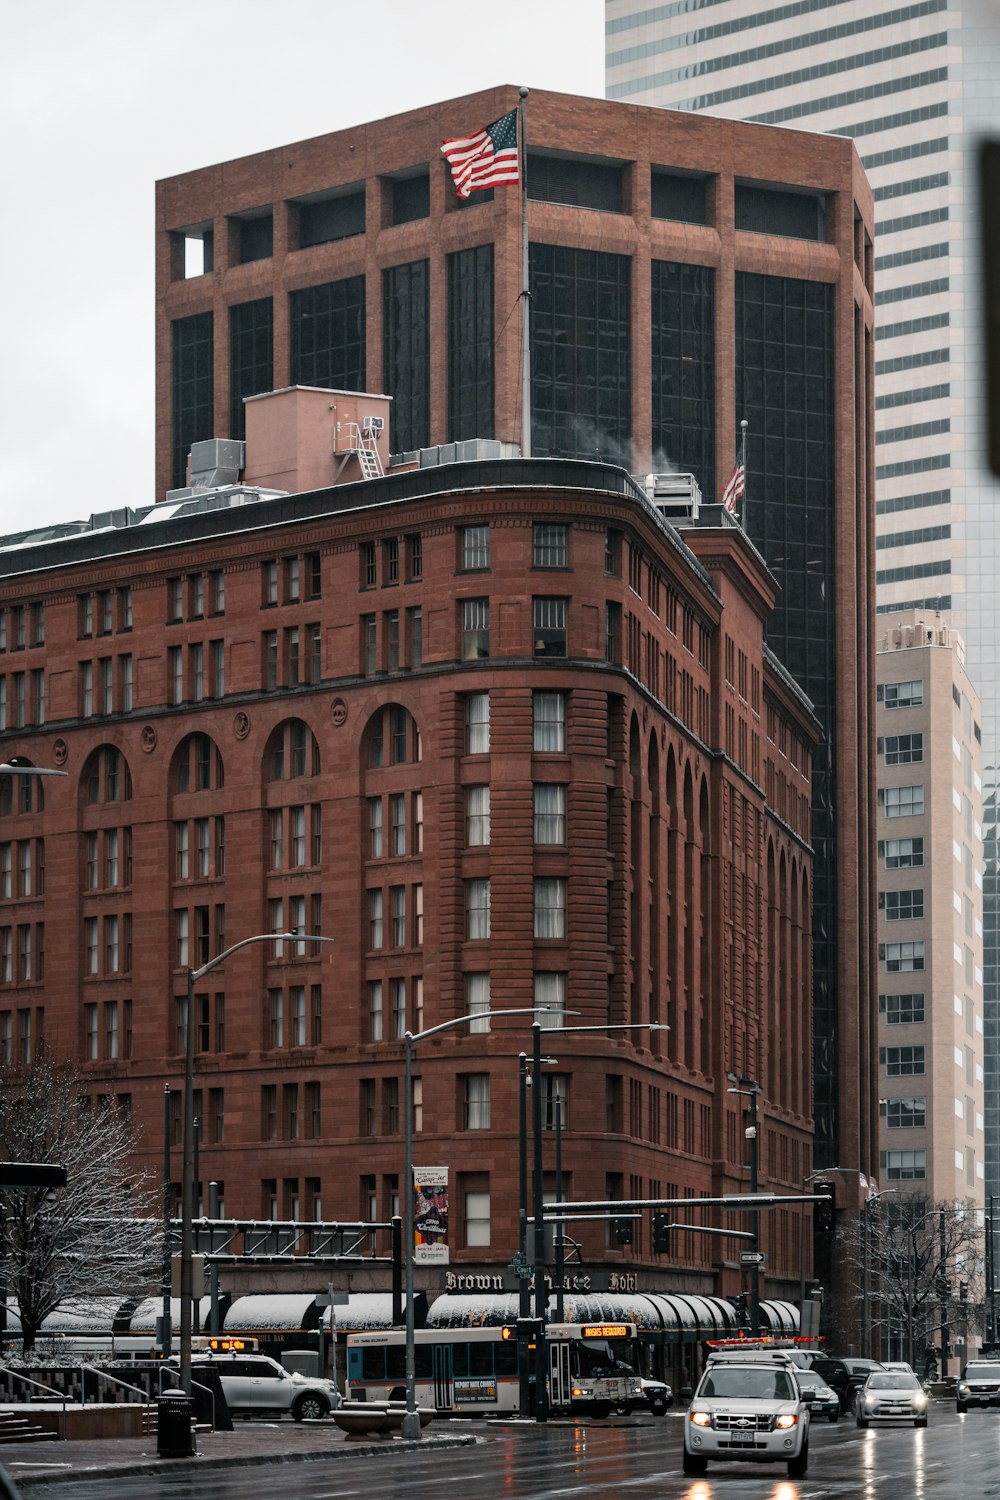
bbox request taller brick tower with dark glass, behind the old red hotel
[156,87,877,1202]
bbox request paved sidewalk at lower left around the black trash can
[0,1422,481,1491]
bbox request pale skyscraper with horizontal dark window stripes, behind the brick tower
[606,0,1000,1193]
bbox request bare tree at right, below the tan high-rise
[838,1193,984,1368]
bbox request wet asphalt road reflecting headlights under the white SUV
[18,1404,1000,1500]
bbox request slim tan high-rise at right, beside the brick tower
[876,611,985,1203]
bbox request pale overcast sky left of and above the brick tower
[0,0,604,533]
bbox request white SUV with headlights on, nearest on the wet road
[684,1352,810,1479]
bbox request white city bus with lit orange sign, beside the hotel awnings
[346,1323,642,1418]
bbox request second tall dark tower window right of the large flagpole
[651,264,717,503]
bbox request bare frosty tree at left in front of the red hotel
[0,1056,160,1352]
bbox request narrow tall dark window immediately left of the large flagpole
[448,245,496,443]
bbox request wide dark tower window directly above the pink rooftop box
[291,276,364,390]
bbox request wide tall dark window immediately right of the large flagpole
[531,245,631,467]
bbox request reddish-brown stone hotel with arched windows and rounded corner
[0,461,819,1295]
